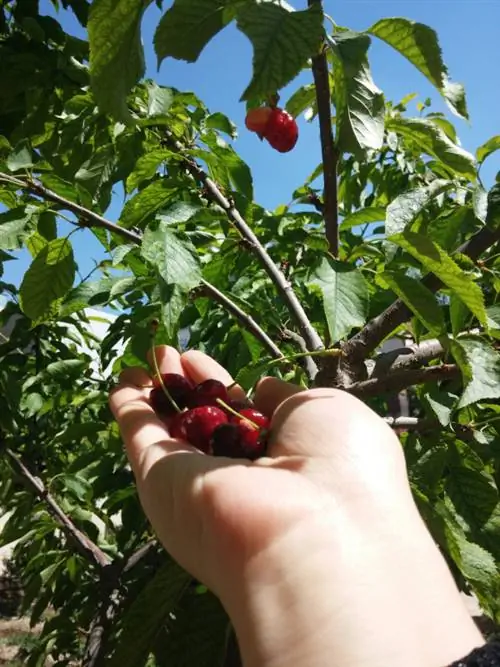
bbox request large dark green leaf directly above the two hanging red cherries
[237,2,324,100]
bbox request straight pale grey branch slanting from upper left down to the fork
[162,132,324,351]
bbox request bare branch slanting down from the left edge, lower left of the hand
[5,447,111,569]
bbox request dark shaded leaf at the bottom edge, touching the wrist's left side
[155,591,229,667]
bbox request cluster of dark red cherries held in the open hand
[150,373,269,461]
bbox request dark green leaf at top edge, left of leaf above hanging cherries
[154,0,238,66]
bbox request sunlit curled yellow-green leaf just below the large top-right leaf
[386,116,476,181]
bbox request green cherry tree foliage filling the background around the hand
[0,0,500,667]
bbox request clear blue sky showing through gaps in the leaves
[4,0,500,283]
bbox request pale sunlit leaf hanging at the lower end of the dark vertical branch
[309,258,368,342]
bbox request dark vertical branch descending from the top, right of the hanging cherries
[308,0,339,257]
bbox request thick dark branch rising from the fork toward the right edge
[344,227,500,361]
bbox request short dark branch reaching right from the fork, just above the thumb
[344,364,460,398]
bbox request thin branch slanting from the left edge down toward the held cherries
[0,173,283,359]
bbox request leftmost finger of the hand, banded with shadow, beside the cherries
[109,385,196,481]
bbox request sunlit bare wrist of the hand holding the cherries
[221,500,483,667]
